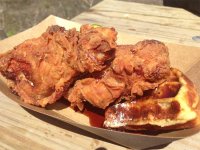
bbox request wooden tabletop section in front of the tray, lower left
[0,93,126,150]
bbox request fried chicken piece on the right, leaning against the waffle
[65,40,170,110]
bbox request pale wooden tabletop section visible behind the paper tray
[72,0,200,47]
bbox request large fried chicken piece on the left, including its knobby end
[0,25,117,107]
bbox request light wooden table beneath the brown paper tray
[0,0,200,150]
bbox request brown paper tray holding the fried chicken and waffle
[0,16,200,149]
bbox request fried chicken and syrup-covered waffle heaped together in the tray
[0,25,200,130]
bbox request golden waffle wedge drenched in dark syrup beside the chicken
[104,68,200,130]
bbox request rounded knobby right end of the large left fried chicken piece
[63,25,117,73]
